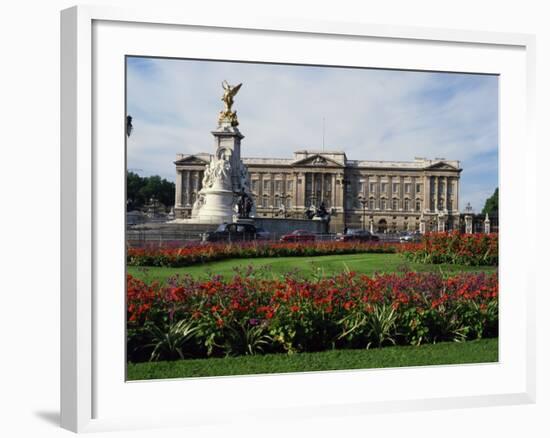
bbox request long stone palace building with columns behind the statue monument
[174,150,462,233]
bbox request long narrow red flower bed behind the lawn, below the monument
[126,242,399,268]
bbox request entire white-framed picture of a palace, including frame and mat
[61,7,536,432]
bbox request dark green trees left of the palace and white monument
[126,172,176,210]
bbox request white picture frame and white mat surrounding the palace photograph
[61,6,536,432]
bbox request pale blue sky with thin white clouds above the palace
[126,57,498,212]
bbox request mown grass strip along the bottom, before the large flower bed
[127,338,498,380]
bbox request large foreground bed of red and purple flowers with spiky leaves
[127,271,498,362]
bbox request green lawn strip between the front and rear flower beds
[128,250,497,282]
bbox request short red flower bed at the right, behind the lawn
[401,232,498,266]
